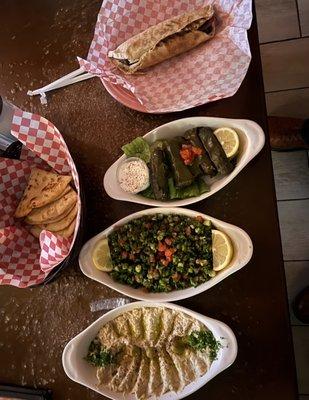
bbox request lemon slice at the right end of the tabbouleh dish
[211,229,233,271]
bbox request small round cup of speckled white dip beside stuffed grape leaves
[117,157,149,193]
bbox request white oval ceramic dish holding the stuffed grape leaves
[104,117,265,207]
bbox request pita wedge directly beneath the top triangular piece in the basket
[25,189,77,225]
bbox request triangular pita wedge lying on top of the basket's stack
[15,168,72,218]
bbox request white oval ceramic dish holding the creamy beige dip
[62,301,237,400]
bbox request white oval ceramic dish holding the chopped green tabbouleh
[79,208,253,302]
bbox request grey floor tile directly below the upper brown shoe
[271,150,309,200]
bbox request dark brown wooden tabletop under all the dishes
[0,0,297,400]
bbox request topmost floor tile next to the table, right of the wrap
[255,0,300,43]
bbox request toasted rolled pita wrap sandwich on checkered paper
[108,5,215,74]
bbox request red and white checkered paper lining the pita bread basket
[0,109,80,288]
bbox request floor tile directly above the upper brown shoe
[266,87,309,118]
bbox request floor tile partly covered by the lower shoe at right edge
[284,261,309,324]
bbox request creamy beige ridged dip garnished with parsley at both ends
[86,307,221,399]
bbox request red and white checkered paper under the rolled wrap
[79,0,252,113]
